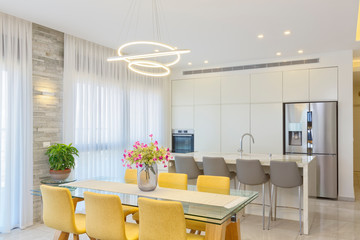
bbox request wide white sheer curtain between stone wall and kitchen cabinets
[64,35,168,179]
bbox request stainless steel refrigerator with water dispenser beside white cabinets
[284,102,338,199]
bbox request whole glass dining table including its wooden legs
[32,177,258,240]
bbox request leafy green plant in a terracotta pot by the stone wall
[45,143,79,180]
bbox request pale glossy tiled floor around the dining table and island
[0,196,360,240]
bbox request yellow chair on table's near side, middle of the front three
[84,192,139,240]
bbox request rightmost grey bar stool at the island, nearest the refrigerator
[268,161,303,234]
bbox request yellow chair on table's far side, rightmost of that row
[186,175,230,233]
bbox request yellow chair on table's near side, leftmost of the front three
[40,185,86,239]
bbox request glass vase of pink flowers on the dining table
[121,134,170,191]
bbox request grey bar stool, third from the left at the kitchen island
[236,159,271,230]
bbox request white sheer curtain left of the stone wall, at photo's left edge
[0,13,33,233]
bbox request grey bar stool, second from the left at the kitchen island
[203,157,236,189]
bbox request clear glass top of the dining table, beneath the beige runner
[32,178,258,224]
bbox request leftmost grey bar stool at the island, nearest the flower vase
[175,156,203,184]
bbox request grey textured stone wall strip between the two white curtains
[32,24,64,221]
